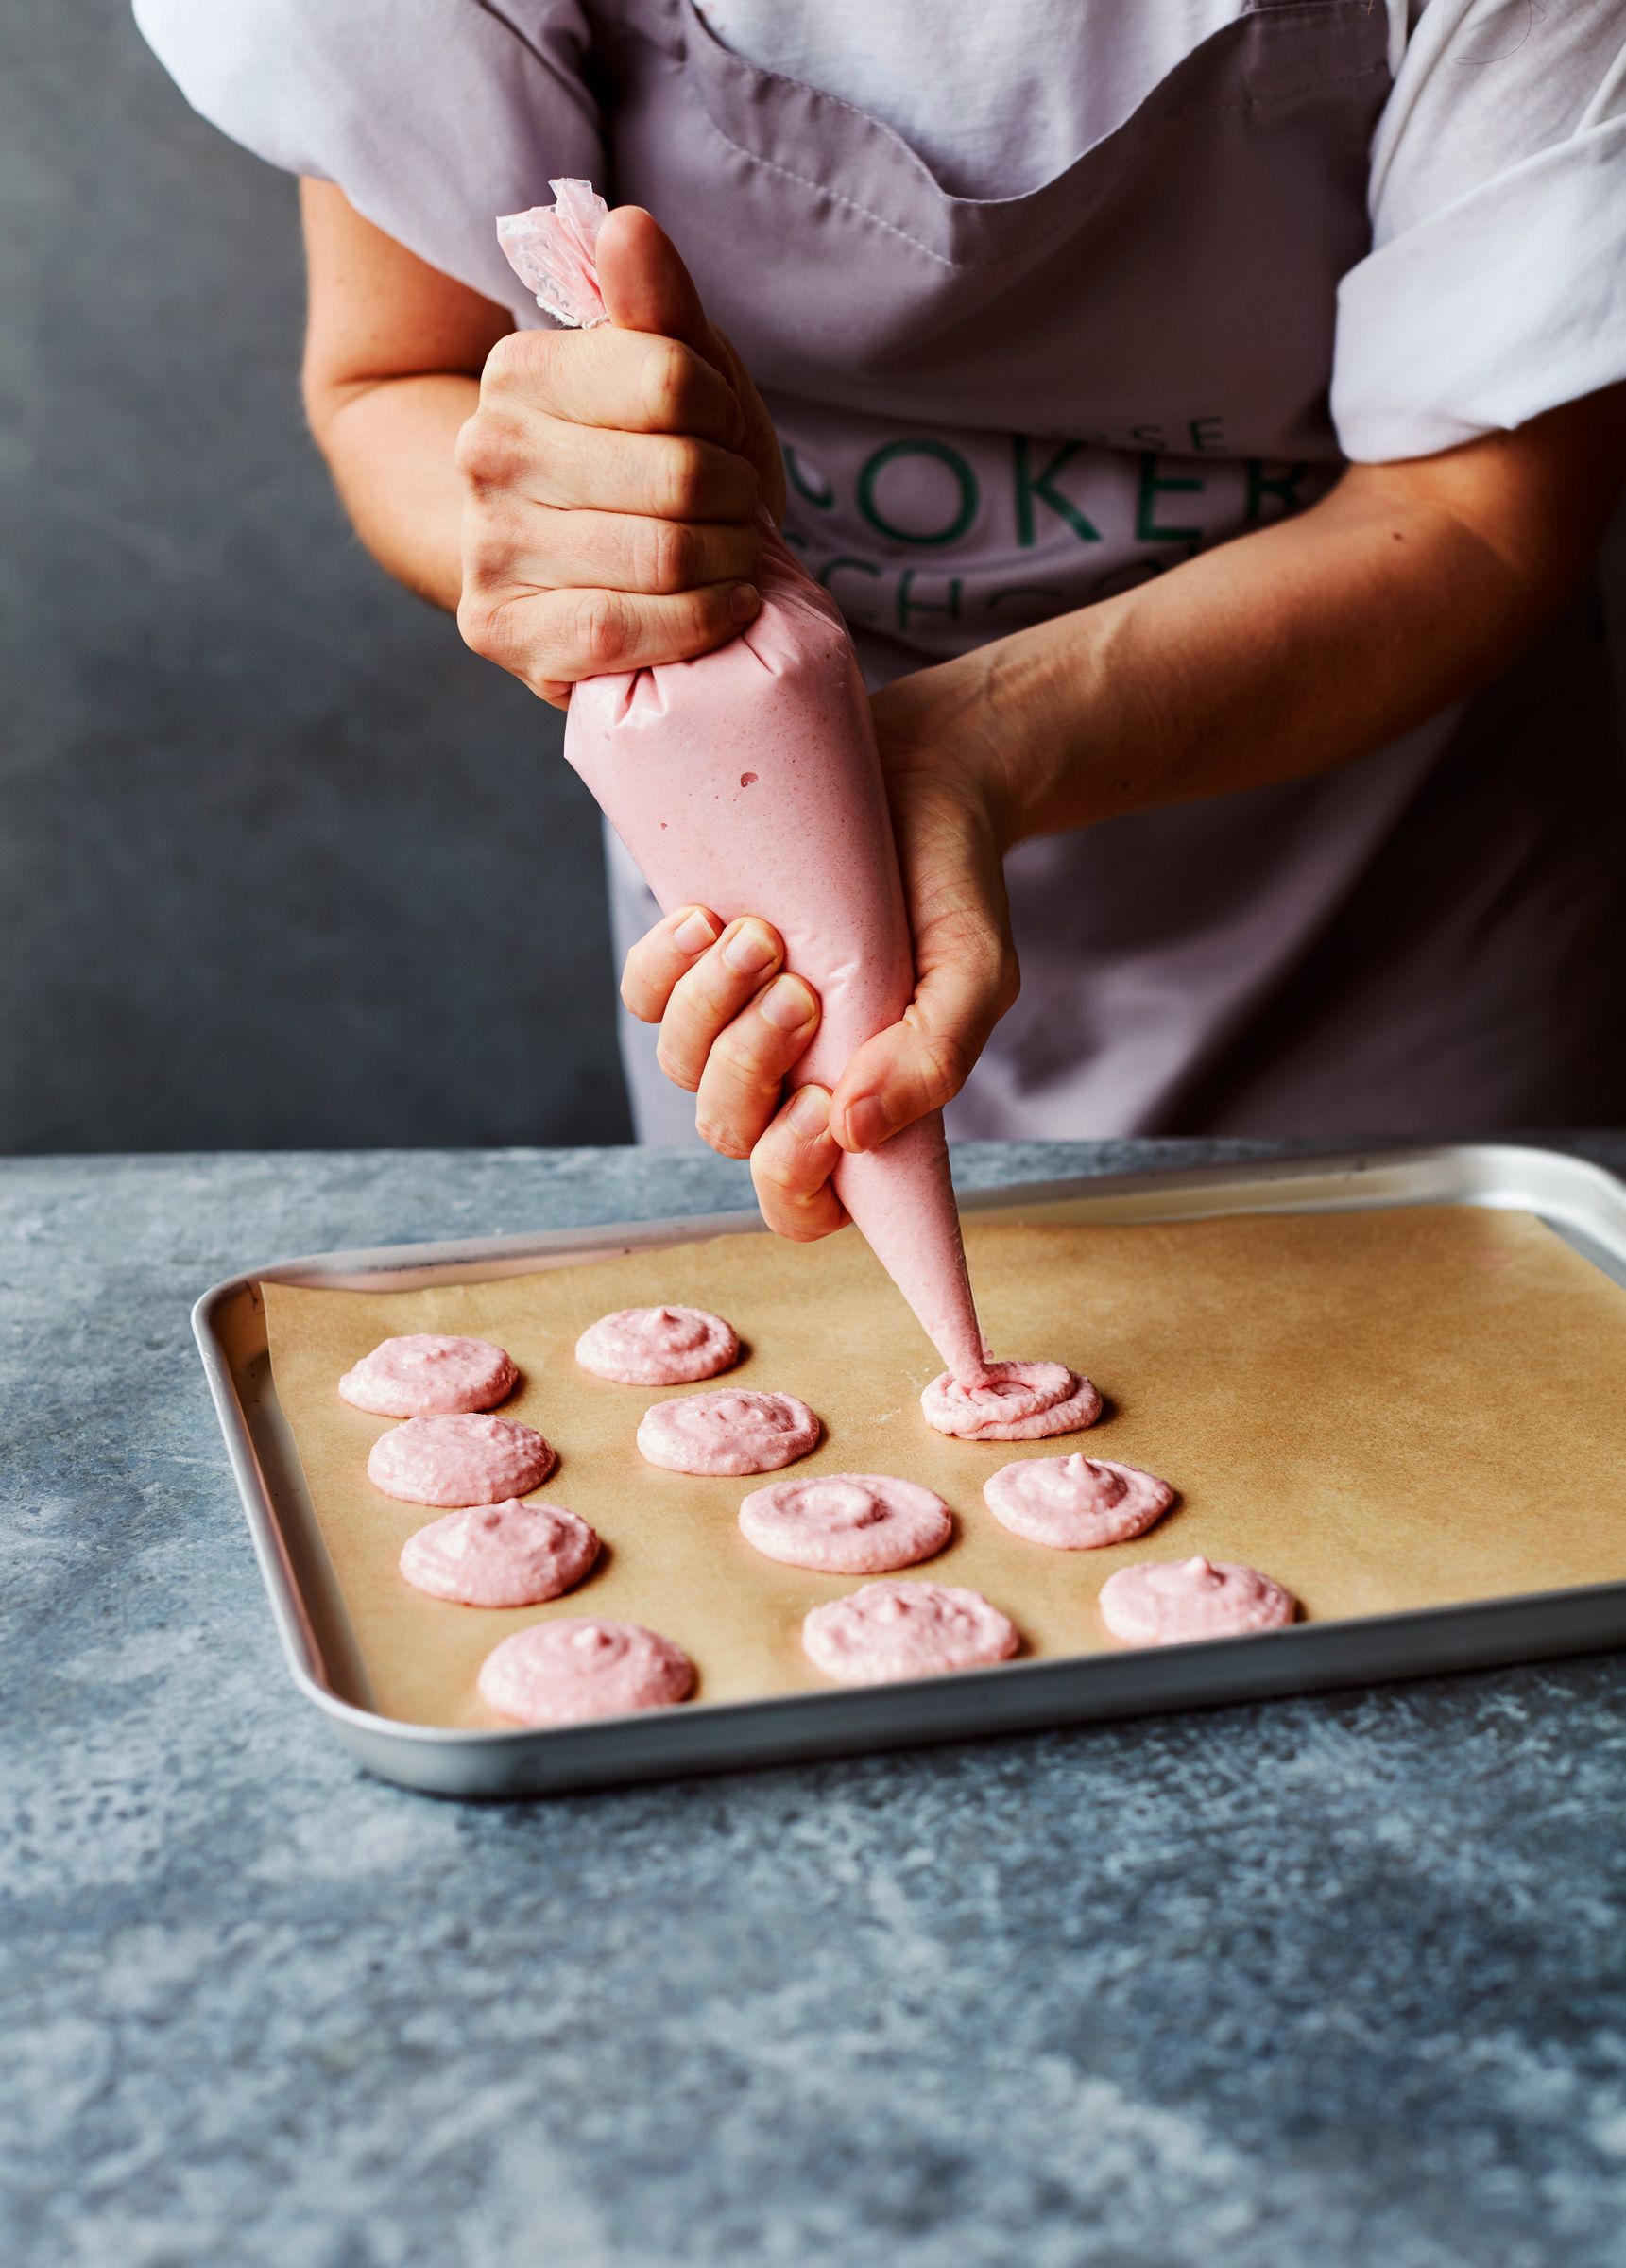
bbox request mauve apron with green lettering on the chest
[578,0,1626,1141]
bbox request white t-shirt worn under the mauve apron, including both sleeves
[134,0,1626,460]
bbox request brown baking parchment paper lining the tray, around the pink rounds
[263,1207,1626,1726]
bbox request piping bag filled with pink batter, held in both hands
[497,181,986,1385]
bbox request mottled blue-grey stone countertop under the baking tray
[0,1139,1626,2268]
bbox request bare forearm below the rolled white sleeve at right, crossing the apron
[978,394,1613,841]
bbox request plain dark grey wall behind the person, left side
[0,0,1626,1152]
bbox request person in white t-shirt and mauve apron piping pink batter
[136,0,1626,1236]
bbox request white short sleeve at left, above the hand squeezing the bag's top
[134,0,603,324]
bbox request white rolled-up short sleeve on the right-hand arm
[1331,0,1626,463]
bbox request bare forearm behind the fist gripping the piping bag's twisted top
[311,372,481,612]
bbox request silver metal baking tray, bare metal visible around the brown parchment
[193,1145,1626,1796]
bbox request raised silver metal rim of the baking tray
[193,1143,1626,1794]
